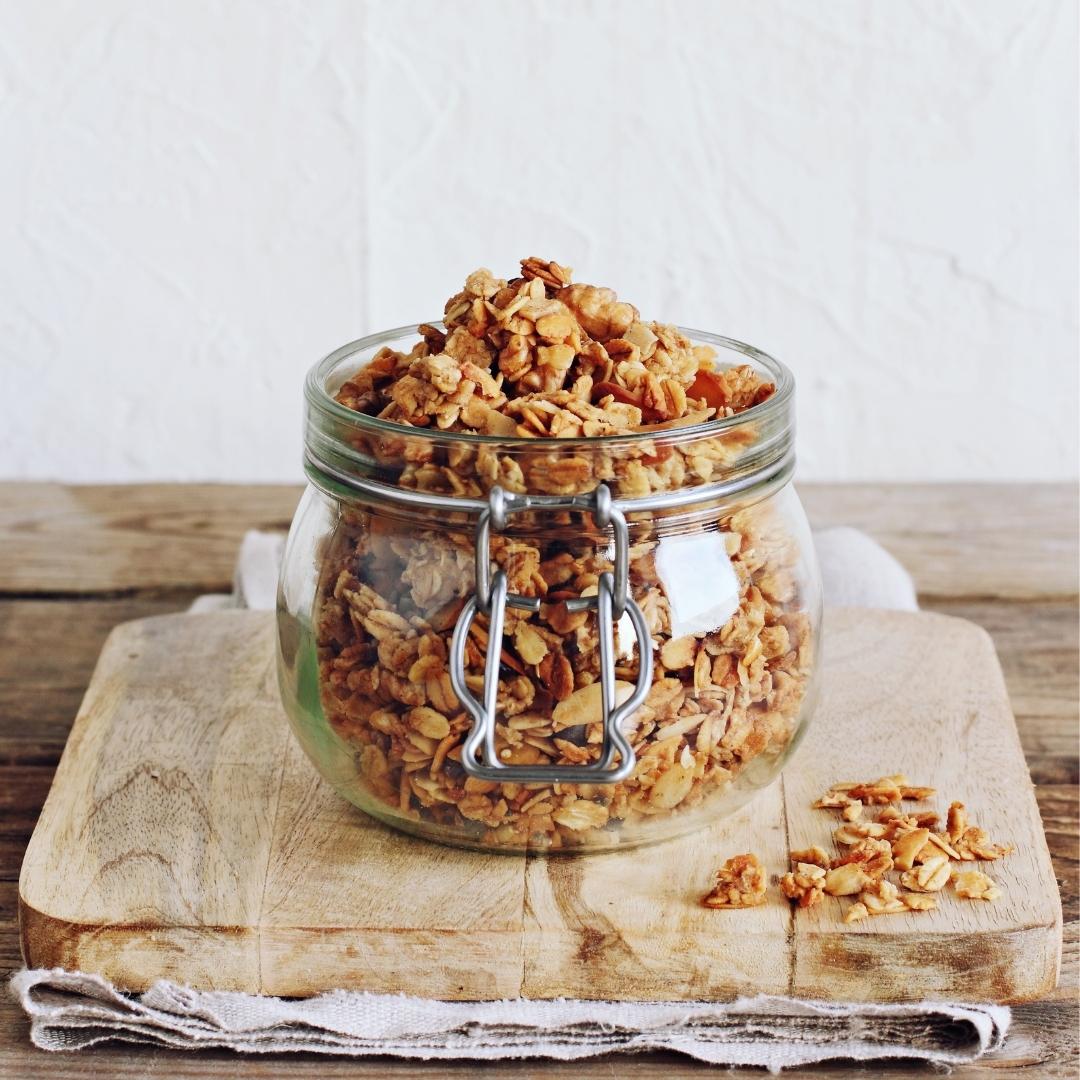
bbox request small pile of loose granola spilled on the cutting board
[701,774,1013,923]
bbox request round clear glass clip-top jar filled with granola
[279,327,821,851]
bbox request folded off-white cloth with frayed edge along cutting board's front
[12,969,1009,1072]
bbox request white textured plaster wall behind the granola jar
[0,0,1078,481]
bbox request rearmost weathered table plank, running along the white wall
[0,483,1077,599]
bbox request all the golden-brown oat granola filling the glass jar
[314,259,814,849]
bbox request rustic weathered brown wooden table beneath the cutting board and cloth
[0,484,1080,1080]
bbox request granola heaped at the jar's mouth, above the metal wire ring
[336,258,775,497]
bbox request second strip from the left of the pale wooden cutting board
[253,734,524,999]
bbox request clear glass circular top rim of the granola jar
[305,320,795,450]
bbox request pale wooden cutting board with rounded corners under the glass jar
[19,610,1061,1001]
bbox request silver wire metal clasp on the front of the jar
[449,484,652,784]
